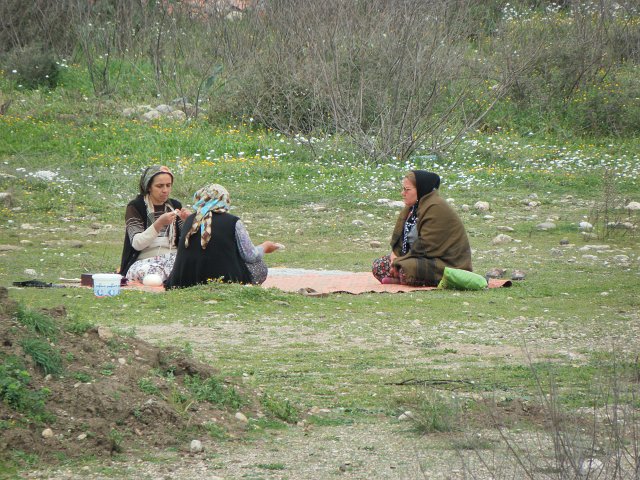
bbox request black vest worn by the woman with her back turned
[165,213,251,288]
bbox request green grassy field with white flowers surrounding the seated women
[0,78,640,476]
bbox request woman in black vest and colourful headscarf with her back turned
[165,184,278,288]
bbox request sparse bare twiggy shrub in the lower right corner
[460,355,640,480]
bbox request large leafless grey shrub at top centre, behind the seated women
[215,0,517,158]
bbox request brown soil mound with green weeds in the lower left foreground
[0,287,262,461]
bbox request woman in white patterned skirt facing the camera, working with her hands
[119,165,191,282]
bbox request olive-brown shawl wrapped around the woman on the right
[391,190,472,286]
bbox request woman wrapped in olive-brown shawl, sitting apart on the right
[372,170,471,286]
